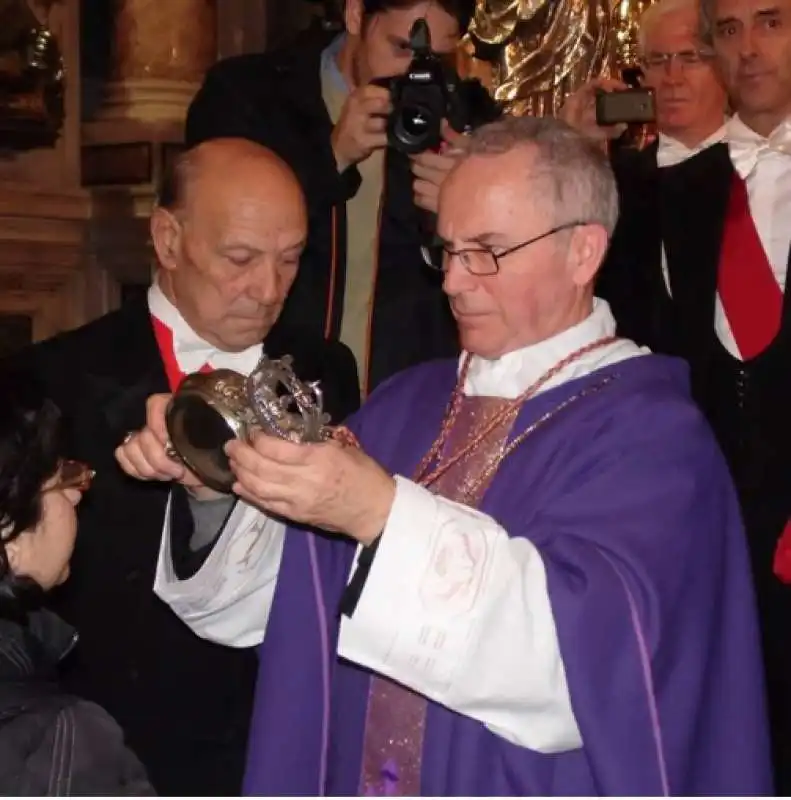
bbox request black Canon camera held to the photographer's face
[373,18,500,155]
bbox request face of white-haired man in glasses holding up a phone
[644,3,725,141]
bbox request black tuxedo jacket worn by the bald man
[7,302,359,796]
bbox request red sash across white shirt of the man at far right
[717,173,783,361]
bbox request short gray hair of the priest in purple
[466,116,618,236]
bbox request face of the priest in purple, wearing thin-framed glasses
[438,149,598,358]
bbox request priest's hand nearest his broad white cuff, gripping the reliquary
[225,432,395,545]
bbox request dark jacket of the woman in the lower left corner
[0,612,154,797]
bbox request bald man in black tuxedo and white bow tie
[7,139,359,796]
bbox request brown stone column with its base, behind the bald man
[81,0,217,318]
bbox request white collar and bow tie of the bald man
[148,281,263,375]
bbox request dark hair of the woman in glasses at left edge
[0,368,62,617]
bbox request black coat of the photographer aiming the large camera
[185,39,459,390]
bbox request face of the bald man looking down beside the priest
[157,156,307,352]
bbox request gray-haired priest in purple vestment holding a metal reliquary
[119,118,772,796]
